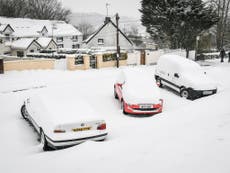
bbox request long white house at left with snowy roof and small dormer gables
[0,17,83,54]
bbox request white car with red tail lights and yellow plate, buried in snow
[21,95,107,151]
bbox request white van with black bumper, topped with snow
[155,55,217,100]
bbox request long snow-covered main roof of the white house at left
[0,17,82,37]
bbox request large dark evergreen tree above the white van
[140,0,219,57]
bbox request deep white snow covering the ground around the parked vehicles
[0,62,230,173]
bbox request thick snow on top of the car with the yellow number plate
[31,92,101,125]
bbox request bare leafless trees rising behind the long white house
[0,0,71,21]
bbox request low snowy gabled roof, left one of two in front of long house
[10,38,41,50]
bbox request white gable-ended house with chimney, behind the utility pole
[83,17,134,50]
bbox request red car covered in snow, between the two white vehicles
[114,69,163,114]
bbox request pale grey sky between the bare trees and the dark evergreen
[60,0,141,18]
